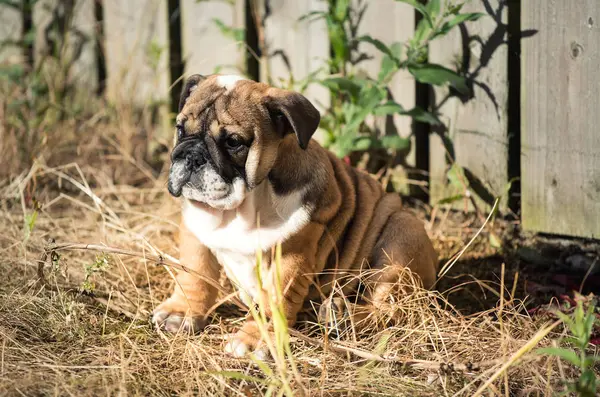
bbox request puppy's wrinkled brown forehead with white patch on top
[177,75,267,130]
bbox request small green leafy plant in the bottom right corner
[537,295,600,397]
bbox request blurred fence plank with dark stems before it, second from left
[33,0,98,94]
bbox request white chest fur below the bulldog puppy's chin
[183,182,311,303]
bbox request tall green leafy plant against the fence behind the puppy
[301,0,484,157]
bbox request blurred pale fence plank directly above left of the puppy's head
[104,0,170,105]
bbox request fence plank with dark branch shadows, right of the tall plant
[429,0,508,208]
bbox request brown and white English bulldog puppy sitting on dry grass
[152,75,438,357]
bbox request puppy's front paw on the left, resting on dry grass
[152,298,206,334]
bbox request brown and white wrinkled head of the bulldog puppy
[168,75,320,209]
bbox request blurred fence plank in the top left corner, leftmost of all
[0,4,23,64]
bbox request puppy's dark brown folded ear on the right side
[264,88,321,149]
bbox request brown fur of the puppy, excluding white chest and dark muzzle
[152,76,437,347]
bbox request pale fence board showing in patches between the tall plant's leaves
[359,0,415,166]
